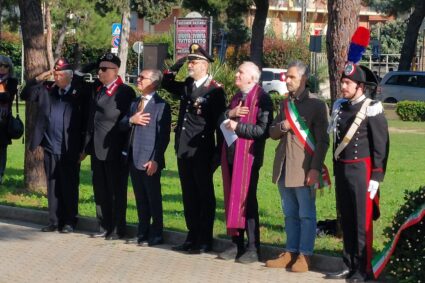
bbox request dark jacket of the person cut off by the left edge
[0,78,18,145]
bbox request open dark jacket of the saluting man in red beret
[21,76,90,159]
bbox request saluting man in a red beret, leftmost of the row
[21,59,90,233]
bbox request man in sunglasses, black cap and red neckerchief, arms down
[86,53,136,240]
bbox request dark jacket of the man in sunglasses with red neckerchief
[86,82,136,161]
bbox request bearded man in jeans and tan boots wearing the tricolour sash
[266,61,330,272]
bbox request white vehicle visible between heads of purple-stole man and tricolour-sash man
[260,68,288,95]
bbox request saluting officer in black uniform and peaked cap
[163,44,226,253]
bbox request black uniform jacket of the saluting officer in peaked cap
[163,73,226,158]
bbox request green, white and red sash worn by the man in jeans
[284,99,331,189]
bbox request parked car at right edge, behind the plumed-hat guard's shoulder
[376,71,425,103]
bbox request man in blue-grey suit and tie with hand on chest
[120,69,171,246]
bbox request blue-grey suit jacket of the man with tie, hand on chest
[120,93,171,170]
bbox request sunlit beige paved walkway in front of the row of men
[0,220,342,283]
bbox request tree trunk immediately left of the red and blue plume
[326,0,361,104]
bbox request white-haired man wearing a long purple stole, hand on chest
[219,62,273,263]
